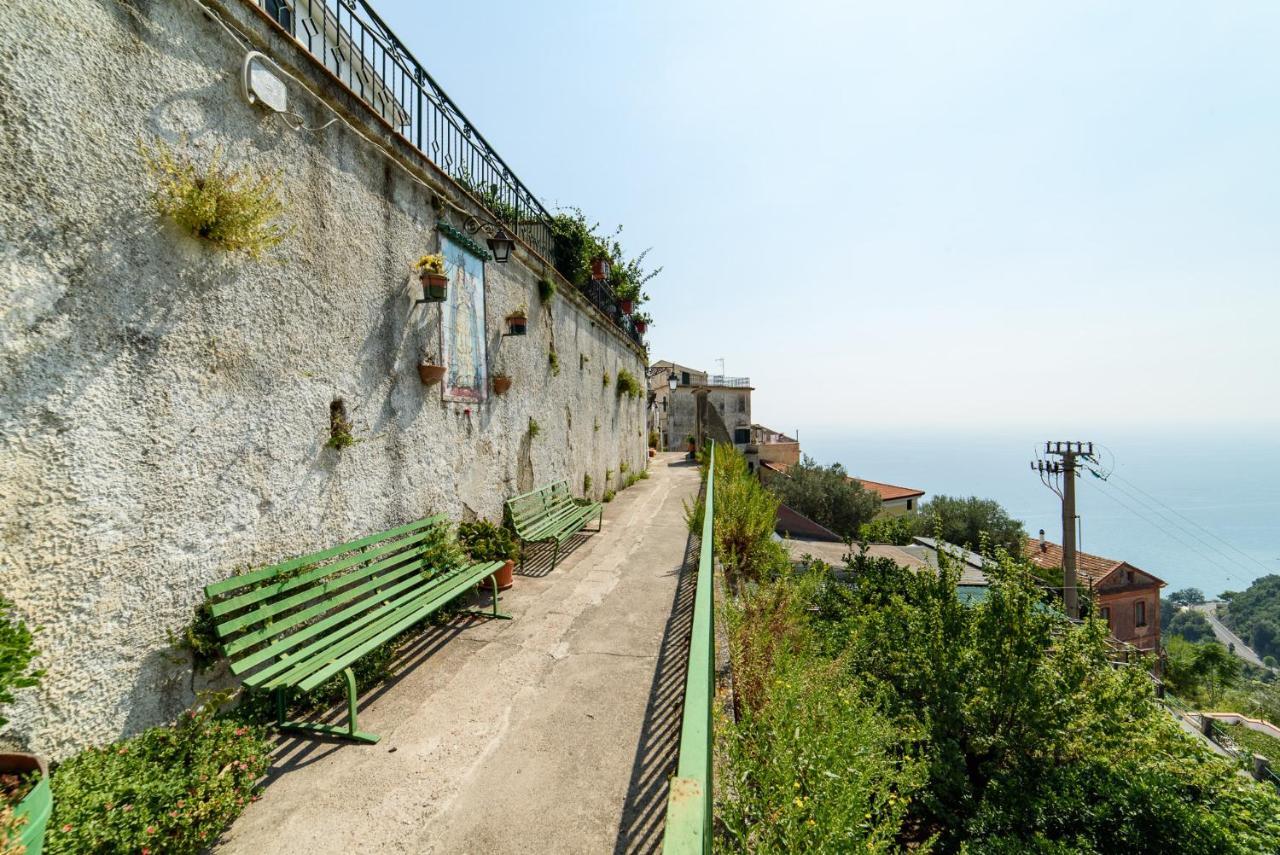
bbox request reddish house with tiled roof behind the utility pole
[1023,529,1165,650]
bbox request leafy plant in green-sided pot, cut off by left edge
[0,596,54,855]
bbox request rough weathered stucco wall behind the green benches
[0,0,645,758]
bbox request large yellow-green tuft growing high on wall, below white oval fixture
[138,140,293,260]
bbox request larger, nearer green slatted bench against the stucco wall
[205,516,509,742]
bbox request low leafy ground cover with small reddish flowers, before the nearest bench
[45,704,270,855]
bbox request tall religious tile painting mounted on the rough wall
[440,234,489,402]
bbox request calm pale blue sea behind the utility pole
[799,429,1280,598]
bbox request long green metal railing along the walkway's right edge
[662,443,716,855]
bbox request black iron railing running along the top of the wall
[251,0,553,259]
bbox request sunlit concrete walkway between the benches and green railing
[219,454,698,855]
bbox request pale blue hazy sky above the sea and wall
[375,0,1280,433]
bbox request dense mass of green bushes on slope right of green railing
[717,550,1280,854]
